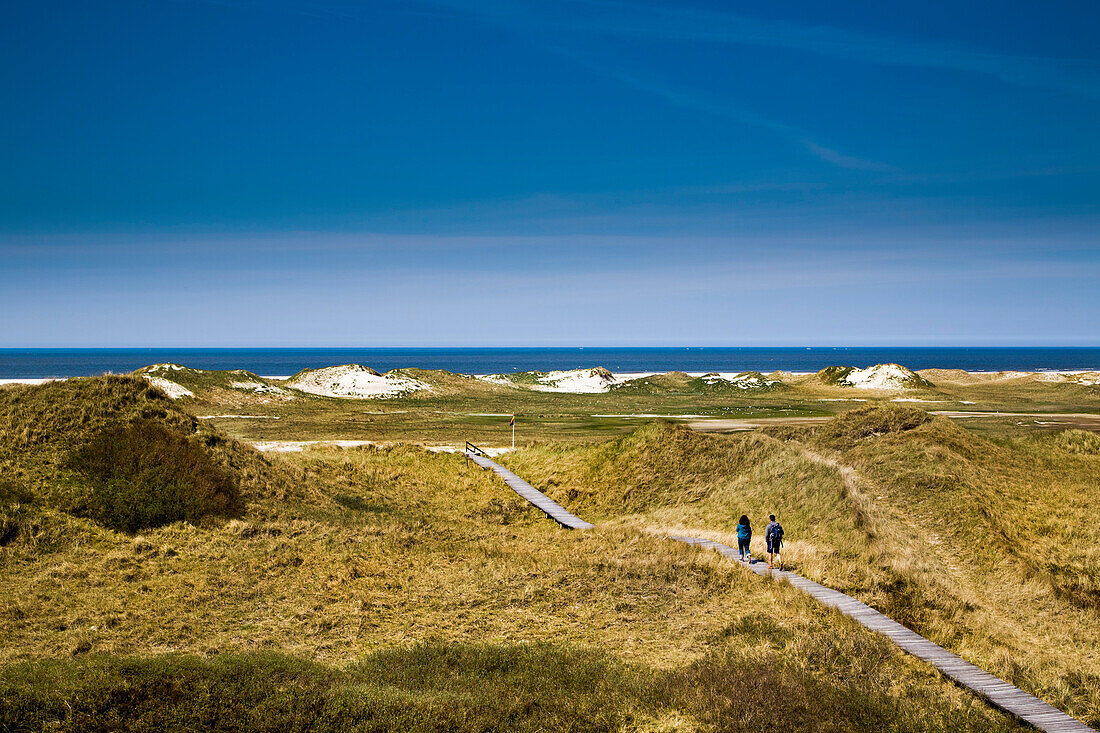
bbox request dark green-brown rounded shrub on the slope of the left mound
[68,420,241,532]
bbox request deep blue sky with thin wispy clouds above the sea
[0,0,1100,347]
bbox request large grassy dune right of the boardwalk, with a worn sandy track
[505,406,1100,725]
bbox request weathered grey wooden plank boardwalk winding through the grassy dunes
[466,451,1096,733]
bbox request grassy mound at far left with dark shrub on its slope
[0,376,277,532]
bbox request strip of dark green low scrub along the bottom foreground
[0,634,1019,733]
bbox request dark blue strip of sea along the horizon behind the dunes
[0,347,1100,379]
